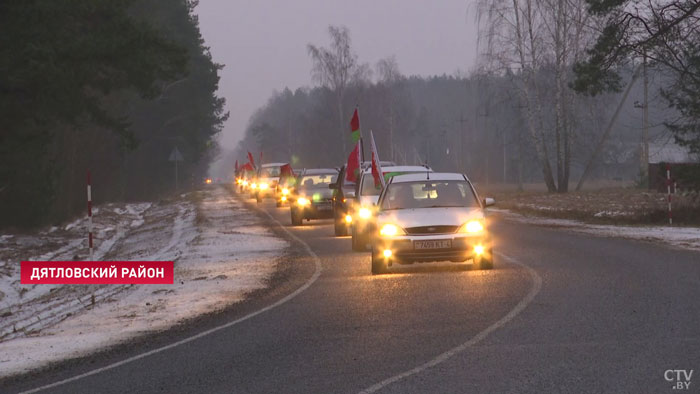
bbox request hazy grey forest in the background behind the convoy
[233,23,680,192]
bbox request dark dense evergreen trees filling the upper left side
[0,0,228,228]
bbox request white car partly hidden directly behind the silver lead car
[351,166,433,251]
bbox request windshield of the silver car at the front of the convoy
[381,181,479,210]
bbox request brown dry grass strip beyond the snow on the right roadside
[480,185,700,226]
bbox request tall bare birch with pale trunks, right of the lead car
[478,0,593,192]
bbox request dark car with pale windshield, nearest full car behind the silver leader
[289,168,338,226]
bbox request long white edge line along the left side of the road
[20,195,321,394]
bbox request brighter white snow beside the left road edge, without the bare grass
[0,188,288,377]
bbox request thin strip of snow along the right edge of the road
[489,209,700,250]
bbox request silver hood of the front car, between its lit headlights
[377,207,484,228]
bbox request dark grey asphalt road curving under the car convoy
[5,188,700,393]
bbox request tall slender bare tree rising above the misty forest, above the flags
[307,26,360,152]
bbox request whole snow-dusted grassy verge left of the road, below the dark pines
[0,188,288,377]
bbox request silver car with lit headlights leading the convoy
[372,173,494,274]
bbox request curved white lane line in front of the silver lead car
[360,253,542,394]
